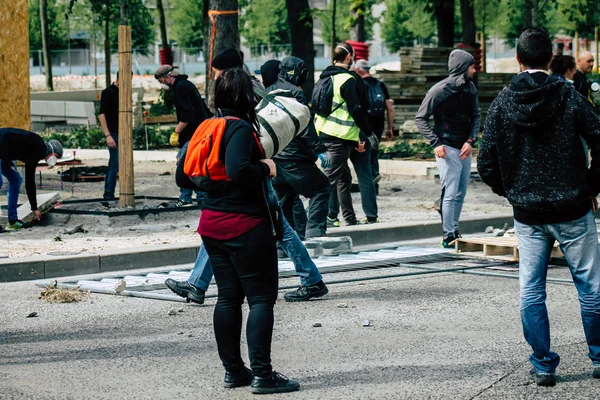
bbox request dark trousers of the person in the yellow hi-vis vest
[329,141,378,224]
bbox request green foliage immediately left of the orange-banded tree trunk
[169,0,208,48]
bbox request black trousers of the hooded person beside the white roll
[273,160,330,240]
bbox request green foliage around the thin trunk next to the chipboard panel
[29,0,67,50]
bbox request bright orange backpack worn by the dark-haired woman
[183,117,262,188]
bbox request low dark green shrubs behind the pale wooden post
[41,126,171,150]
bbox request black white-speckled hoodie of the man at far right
[477,72,600,225]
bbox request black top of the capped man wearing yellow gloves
[173,75,211,147]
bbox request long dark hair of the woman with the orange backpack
[215,68,259,132]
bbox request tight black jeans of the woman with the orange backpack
[202,220,279,376]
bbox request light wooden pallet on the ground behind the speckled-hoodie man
[454,237,563,261]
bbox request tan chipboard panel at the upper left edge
[0,0,31,129]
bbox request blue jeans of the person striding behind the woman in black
[188,180,323,291]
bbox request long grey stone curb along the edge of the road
[0,215,513,282]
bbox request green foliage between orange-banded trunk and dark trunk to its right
[239,0,290,47]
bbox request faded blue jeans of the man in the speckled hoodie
[515,211,600,374]
